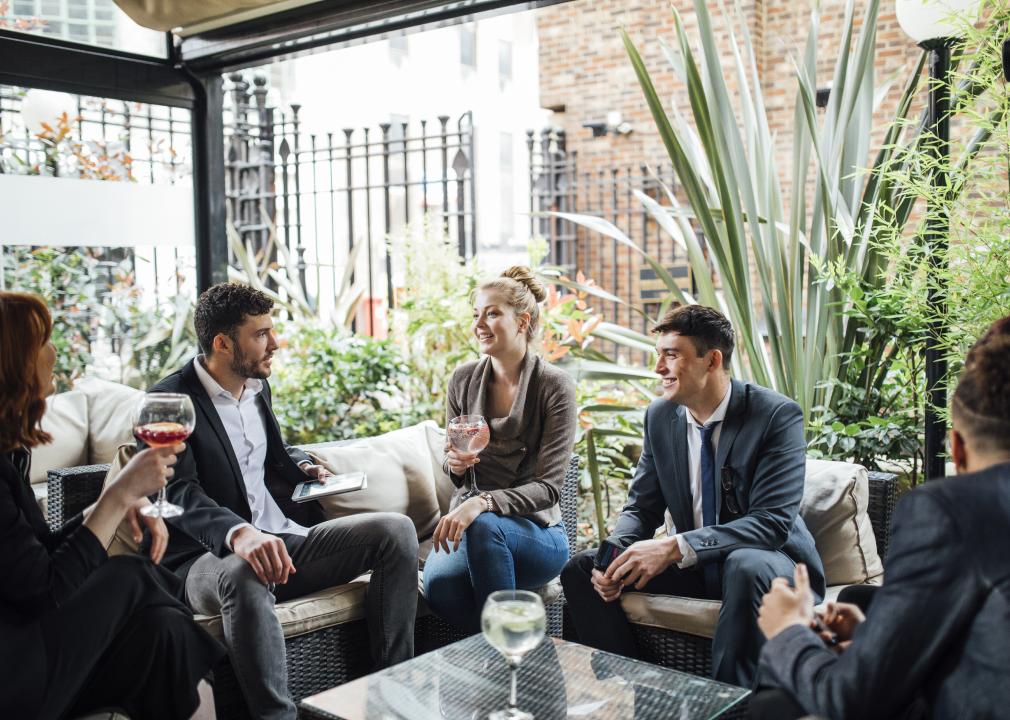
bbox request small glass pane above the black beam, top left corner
[0,0,168,58]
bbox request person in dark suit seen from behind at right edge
[751,318,1010,720]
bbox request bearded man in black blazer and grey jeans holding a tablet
[150,283,417,720]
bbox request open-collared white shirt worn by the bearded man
[193,355,309,547]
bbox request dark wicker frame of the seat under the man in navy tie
[632,473,898,677]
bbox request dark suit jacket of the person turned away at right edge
[761,462,1010,720]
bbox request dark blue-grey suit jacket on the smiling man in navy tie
[613,380,824,597]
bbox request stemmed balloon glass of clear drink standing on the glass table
[481,590,547,720]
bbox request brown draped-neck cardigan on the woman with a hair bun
[445,350,578,527]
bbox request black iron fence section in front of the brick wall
[526,128,691,354]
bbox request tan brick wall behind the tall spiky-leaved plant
[537,0,920,329]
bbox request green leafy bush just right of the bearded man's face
[274,322,423,444]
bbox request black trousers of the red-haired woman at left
[37,555,224,720]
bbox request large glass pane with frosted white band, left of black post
[0,83,196,391]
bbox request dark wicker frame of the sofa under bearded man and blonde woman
[46,455,579,720]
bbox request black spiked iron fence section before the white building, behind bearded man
[225,74,477,333]
